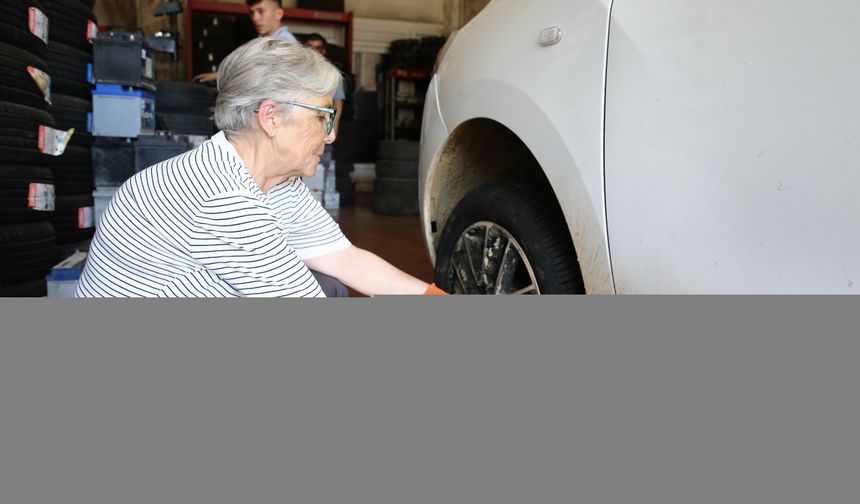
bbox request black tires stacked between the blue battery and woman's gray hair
[155,81,215,136]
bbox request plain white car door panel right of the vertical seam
[606,0,860,293]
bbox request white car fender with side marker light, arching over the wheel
[419,0,613,293]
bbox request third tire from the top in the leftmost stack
[0,102,54,165]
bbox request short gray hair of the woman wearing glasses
[215,37,340,136]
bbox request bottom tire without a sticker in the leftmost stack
[0,222,57,287]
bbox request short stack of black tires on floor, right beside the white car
[373,140,418,215]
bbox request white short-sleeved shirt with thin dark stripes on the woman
[75,132,350,297]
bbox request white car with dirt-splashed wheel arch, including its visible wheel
[419,0,860,294]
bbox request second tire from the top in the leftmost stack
[0,43,48,110]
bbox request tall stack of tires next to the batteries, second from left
[44,0,96,259]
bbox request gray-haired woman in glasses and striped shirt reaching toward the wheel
[76,37,441,297]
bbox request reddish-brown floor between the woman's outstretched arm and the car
[334,192,433,297]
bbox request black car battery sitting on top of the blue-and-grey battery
[93,31,155,91]
